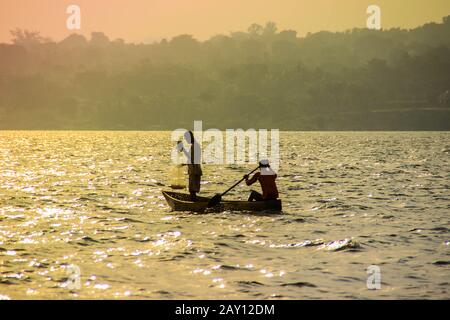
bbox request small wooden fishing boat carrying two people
[162,191,282,213]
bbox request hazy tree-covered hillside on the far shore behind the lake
[0,16,450,130]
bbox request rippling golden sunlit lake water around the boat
[0,131,450,299]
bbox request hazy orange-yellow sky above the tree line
[0,0,450,42]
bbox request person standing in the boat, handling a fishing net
[177,131,203,201]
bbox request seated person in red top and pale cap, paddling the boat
[244,160,278,201]
